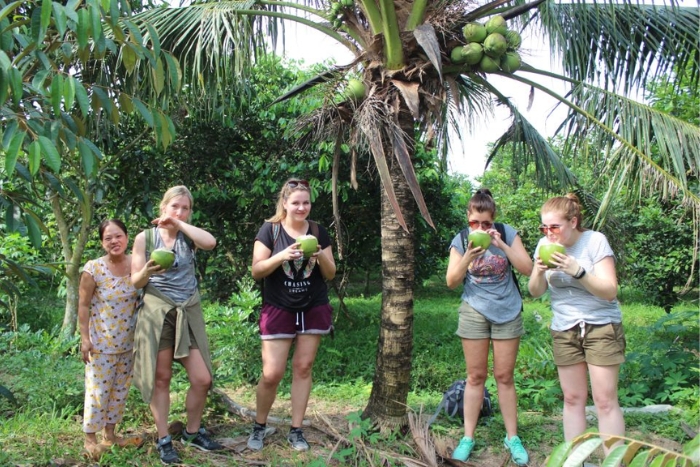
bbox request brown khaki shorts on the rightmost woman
[550,323,627,366]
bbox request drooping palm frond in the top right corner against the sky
[540,0,700,94]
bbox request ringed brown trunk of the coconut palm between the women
[363,123,416,430]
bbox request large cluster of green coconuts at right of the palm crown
[450,16,522,73]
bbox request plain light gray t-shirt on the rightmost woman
[534,230,622,331]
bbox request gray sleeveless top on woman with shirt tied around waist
[146,227,197,303]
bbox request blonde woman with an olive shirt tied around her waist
[131,186,223,464]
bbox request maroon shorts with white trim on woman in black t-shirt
[259,303,333,339]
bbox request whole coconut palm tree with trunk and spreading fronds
[133,0,700,427]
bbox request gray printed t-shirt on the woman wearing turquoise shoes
[450,224,522,324]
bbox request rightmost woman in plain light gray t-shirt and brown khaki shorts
[528,193,625,454]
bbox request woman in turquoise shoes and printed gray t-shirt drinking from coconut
[446,188,532,465]
